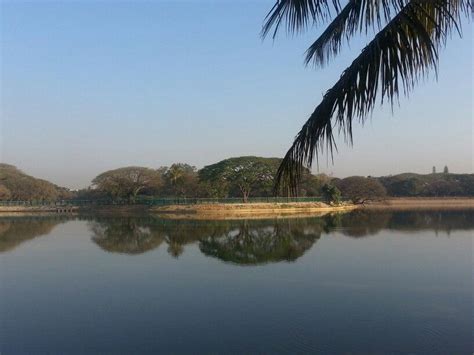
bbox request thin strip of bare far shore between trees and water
[0,197,474,219]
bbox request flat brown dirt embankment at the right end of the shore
[362,197,474,210]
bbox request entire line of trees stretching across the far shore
[0,156,474,203]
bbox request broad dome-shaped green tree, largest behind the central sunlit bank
[199,156,281,203]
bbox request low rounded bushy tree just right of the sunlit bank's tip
[338,176,387,204]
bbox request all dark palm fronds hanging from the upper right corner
[262,0,474,189]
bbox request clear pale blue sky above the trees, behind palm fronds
[0,0,474,188]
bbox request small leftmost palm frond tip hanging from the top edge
[262,0,340,38]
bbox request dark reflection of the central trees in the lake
[90,217,324,264]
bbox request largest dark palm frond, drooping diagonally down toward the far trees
[276,0,472,195]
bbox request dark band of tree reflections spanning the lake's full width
[0,210,474,265]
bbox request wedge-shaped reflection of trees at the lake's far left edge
[0,216,68,253]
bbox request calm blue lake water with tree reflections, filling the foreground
[0,211,474,355]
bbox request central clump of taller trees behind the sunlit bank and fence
[77,156,331,202]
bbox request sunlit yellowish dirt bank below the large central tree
[151,202,356,219]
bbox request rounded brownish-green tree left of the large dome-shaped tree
[92,166,162,202]
